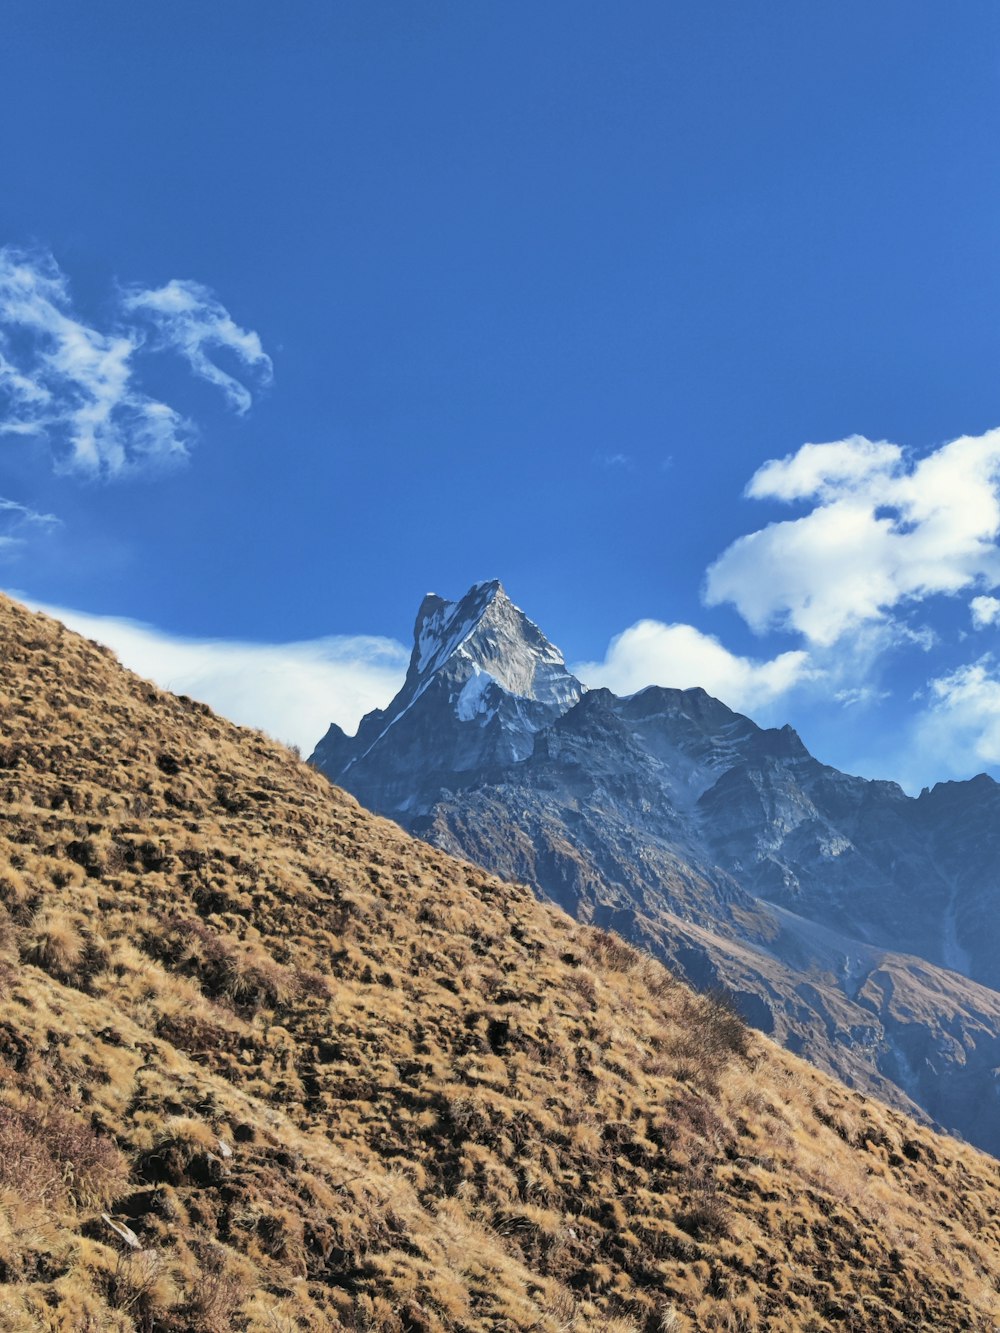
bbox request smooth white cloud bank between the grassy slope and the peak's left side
[28,601,409,754]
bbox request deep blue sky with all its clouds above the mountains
[0,0,1000,788]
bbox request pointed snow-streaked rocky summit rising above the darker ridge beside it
[312,580,583,817]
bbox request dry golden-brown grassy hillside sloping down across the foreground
[0,600,1000,1333]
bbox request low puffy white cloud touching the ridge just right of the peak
[573,620,812,709]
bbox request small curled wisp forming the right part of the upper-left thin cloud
[121,279,272,415]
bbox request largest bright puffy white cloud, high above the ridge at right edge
[705,429,1000,647]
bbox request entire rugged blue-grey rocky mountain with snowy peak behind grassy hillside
[313,583,1000,1153]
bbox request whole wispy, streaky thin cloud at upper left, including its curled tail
[0,247,271,477]
